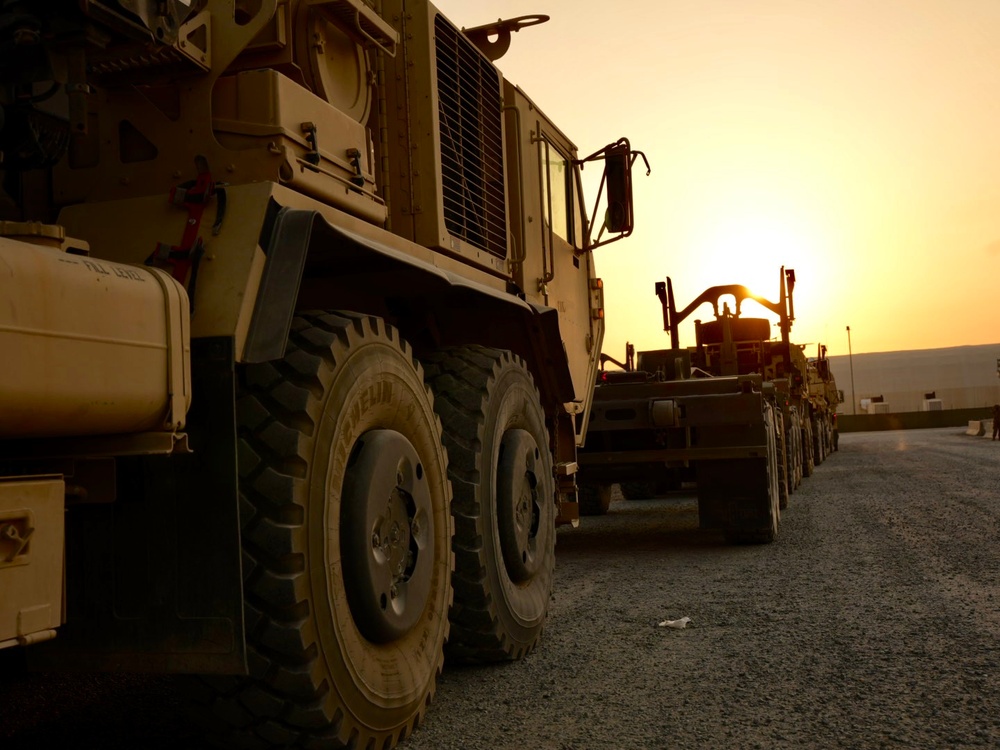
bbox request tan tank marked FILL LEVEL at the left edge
[0,232,191,438]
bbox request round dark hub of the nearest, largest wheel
[340,430,434,643]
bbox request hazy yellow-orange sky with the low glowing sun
[435,0,1000,358]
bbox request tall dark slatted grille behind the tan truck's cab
[434,16,507,258]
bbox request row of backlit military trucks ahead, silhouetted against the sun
[579,268,837,543]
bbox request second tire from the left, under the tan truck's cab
[424,346,556,661]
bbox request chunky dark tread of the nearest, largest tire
[197,312,443,748]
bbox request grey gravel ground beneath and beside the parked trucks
[0,428,1000,750]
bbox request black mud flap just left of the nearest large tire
[28,338,246,674]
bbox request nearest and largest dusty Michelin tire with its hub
[195,313,453,748]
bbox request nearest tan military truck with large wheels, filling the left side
[0,0,638,748]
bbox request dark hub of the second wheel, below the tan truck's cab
[496,430,541,583]
